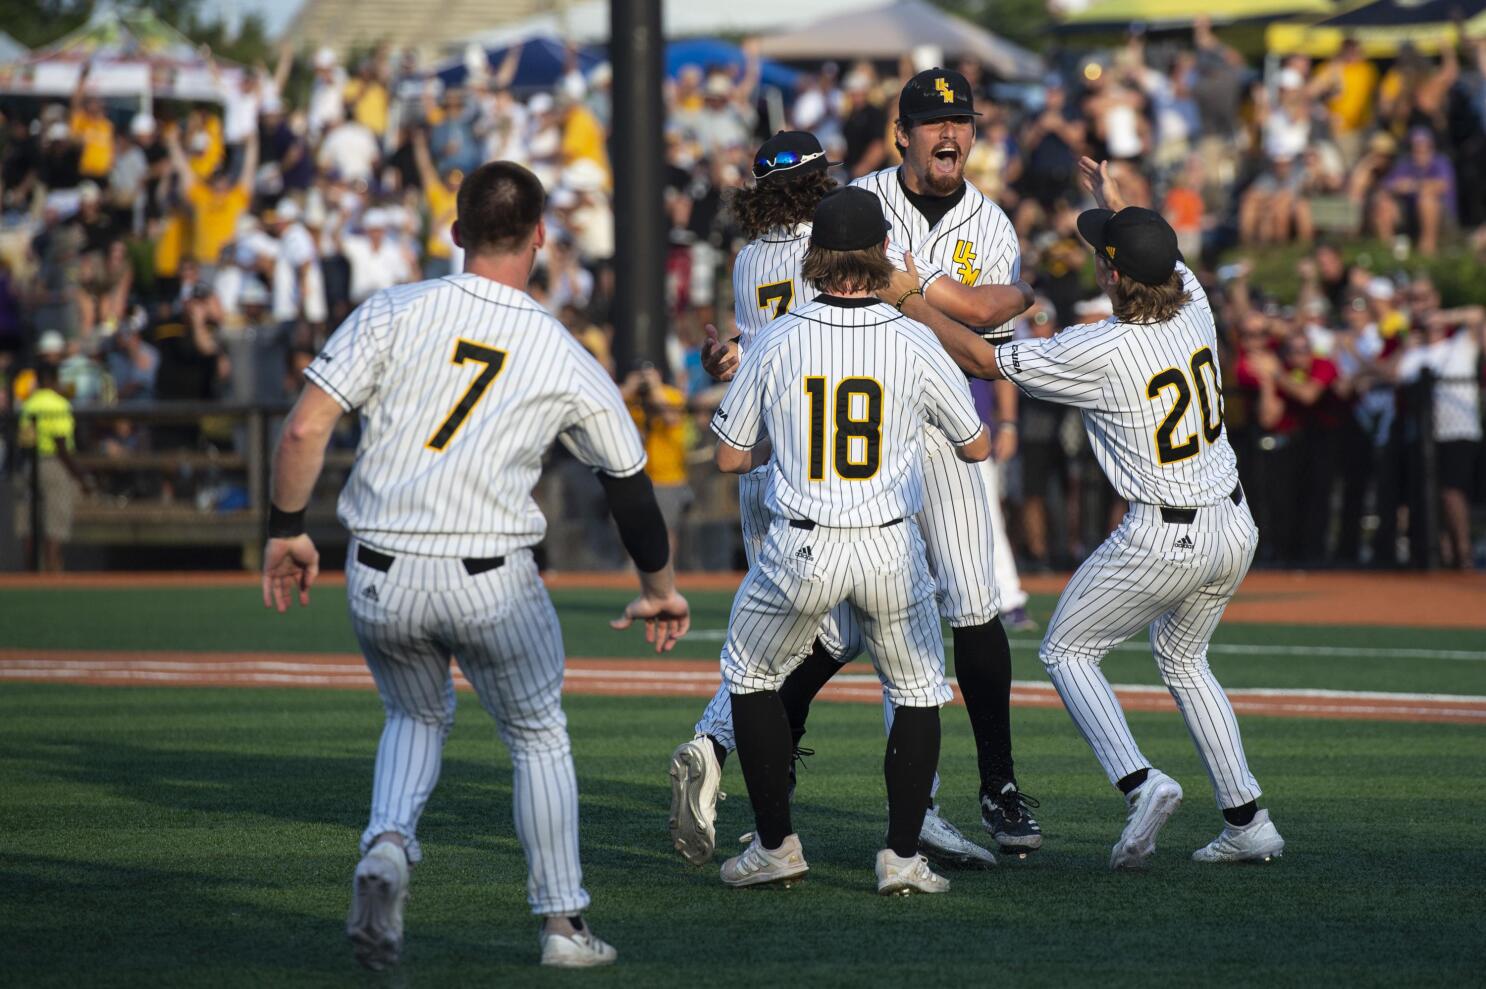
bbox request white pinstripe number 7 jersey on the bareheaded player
[305,273,645,557]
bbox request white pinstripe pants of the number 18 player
[722,518,953,707]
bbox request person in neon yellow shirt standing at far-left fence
[15,361,83,570]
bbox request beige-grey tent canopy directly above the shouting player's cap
[761,0,1043,79]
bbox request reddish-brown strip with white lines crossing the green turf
[0,649,1486,725]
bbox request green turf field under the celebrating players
[0,587,1486,986]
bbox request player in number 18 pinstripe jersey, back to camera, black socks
[712,189,991,894]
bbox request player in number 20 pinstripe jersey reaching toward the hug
[905,159,1285,869]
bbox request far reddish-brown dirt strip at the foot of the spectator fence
[0,572,1486,630]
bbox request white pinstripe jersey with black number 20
[996,264,1238,508]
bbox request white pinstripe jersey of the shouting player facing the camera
[851,165,1021,336]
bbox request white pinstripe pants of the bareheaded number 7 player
[346,541,588,916]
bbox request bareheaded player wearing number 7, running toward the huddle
[263,162,690,968]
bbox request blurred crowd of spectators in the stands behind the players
[0,24,1486,569]
